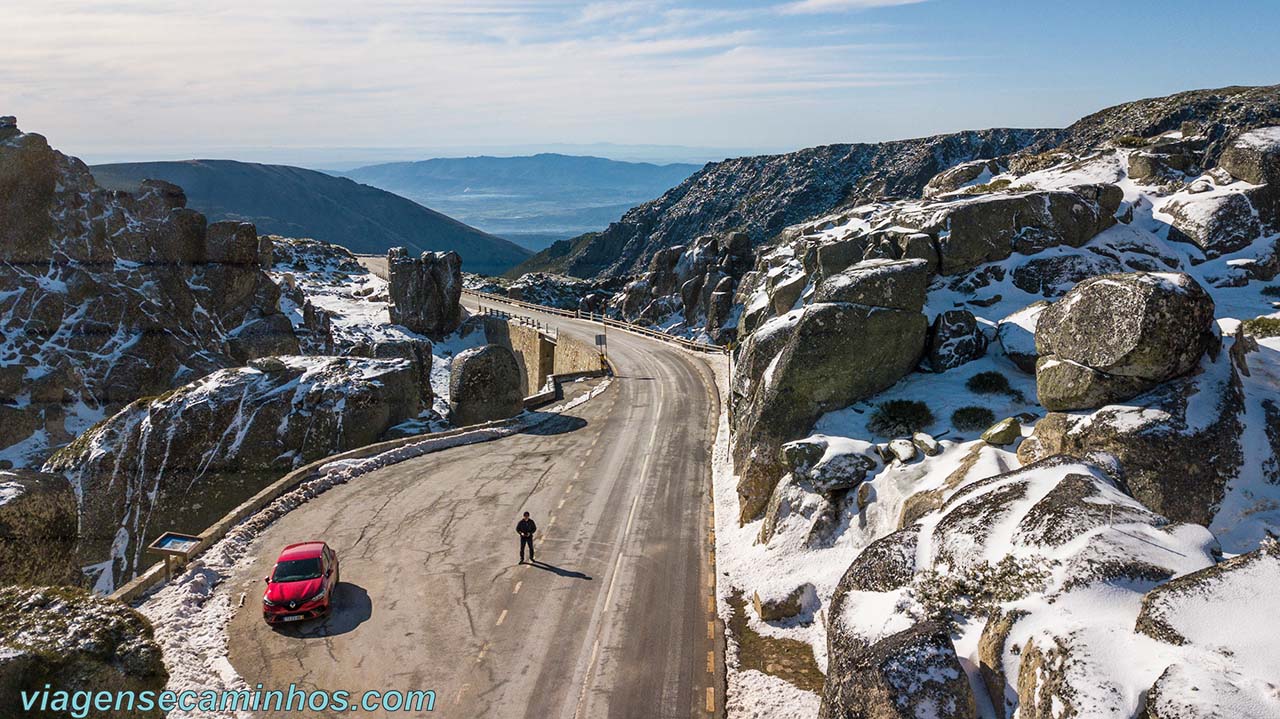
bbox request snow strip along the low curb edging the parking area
[138,379,611,719]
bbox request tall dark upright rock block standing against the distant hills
[387,247,462,340]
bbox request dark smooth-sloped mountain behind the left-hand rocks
[91,160,530,274]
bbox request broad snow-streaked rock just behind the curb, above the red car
[45,357,420,590]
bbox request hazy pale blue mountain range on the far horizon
[334,154,700,249]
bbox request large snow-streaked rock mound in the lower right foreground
[824,457,1218,719]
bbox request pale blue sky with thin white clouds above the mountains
[0,0,1280,166]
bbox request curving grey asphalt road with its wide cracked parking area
[228,294,724,719]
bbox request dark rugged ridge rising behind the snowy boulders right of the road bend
[512,129,1057,278]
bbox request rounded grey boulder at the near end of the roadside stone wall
[449,344,525,426]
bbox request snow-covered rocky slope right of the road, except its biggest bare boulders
[717,114,1280,719]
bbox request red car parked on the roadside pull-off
[262,541,338,624]
